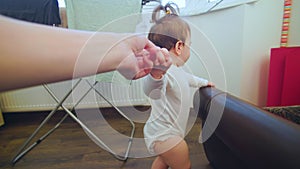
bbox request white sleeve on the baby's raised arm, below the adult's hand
[143,74,166,99]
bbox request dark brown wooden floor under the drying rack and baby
[0,107,212,169]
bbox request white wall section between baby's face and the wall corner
[186,7,244,95]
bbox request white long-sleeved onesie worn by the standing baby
[143,65,208,154]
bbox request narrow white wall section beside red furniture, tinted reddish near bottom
[240,0,284,106]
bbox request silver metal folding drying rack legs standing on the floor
[11,79,135,165]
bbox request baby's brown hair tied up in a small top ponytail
[148,3,191,50]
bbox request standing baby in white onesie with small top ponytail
[144,4,213,169]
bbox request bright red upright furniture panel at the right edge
[267,47,300,106]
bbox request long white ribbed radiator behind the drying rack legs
[0,80,149,112]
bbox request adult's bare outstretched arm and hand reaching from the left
[0,15,164,91]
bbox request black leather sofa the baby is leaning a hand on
[194,87,300,169]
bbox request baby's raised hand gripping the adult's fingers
[150,48,172,79]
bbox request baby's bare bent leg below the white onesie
[154,137,191,169]
